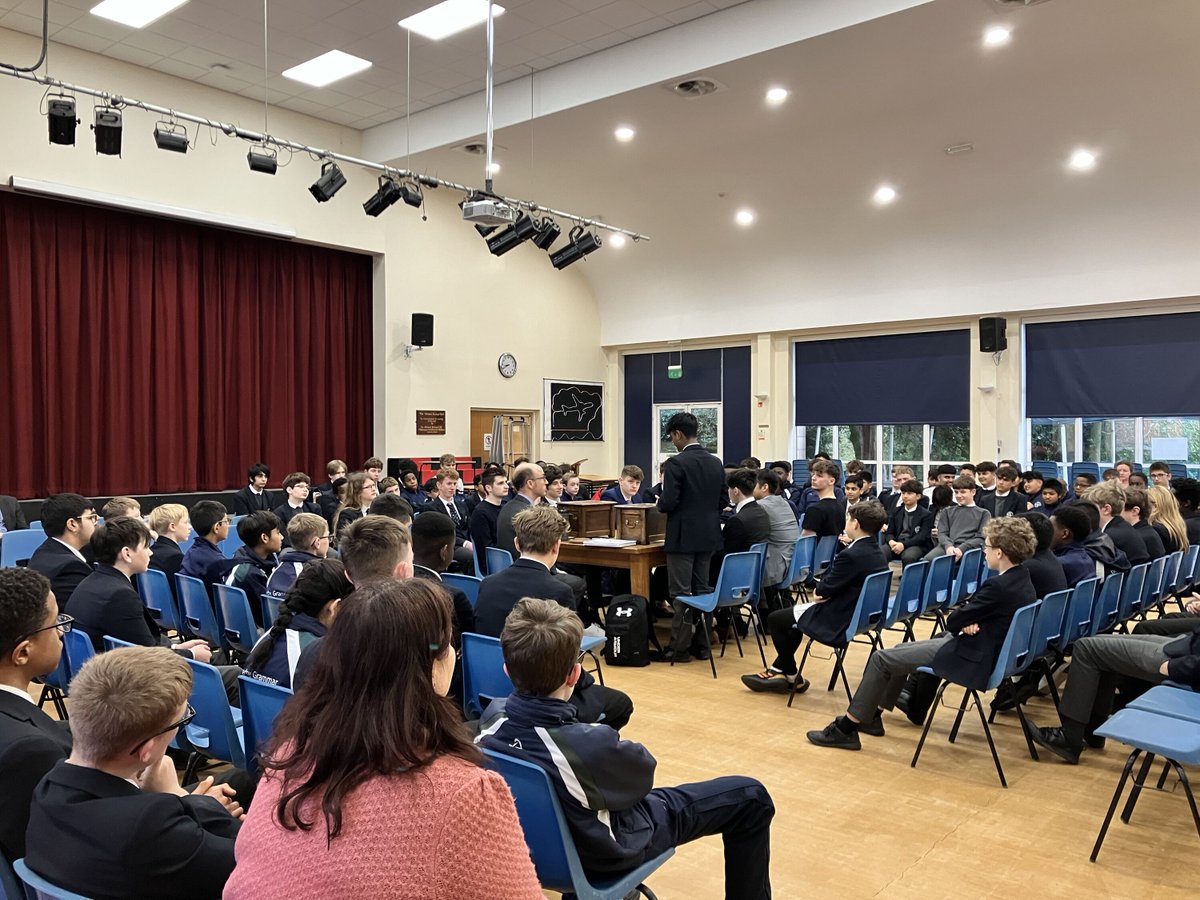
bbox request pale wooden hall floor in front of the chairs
[583,619,1200,900]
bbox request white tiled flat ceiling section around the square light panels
[0,0,744,128]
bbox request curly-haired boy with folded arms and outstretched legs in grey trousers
[808,517,1037,750]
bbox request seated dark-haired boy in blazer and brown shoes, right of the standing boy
[742,500,888,694]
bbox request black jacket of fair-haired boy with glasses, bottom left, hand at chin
[25,761,241,900]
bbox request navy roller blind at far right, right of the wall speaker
[1025,312,1200,419]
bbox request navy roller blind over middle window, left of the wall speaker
[796,330,971,425]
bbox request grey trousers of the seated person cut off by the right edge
[1058,635,1175,728]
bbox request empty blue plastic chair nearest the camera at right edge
[1091,710,1200,863]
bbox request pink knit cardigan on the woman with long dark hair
[224,756,544,900]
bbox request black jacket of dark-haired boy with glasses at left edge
[0,691,71,862]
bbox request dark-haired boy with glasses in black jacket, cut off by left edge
[0,569,71,862]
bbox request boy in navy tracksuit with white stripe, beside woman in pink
[475,599,775,900]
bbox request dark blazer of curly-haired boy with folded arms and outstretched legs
[934,565,1038,690]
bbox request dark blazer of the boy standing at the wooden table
[659,444,725,553]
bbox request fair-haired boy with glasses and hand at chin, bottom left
[25,647,242,898]
